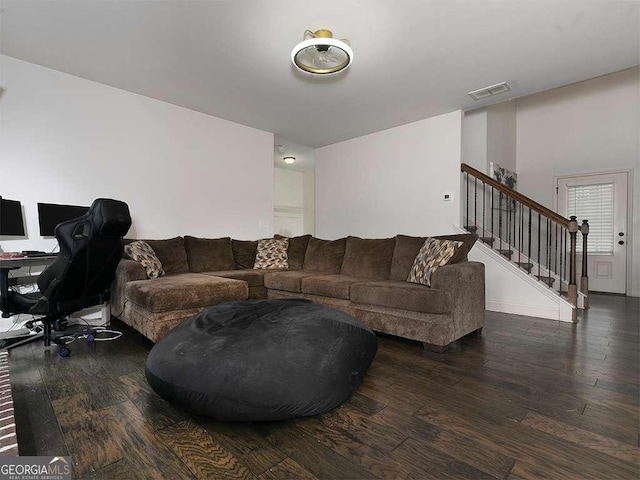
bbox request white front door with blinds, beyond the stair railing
[557,172,628,294]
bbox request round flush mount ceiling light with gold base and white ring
[291,30,353,75]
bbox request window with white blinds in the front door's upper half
[567,183,614,255]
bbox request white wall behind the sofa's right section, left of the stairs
[316,111,462,239]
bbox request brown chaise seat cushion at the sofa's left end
[125,273,249,313]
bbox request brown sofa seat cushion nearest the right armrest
[350,280,453,314]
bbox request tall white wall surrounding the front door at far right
[516,67,640,296]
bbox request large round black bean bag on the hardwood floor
[146,299,378,422]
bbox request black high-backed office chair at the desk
[3,198,131,357]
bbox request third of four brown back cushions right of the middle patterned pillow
[340,237,395,282]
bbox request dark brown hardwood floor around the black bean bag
[10,295,640,480]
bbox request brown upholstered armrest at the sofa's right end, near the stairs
[431,262,486,338]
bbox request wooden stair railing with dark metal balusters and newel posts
[461,163,589,322]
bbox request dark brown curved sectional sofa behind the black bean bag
[111,234,485,351]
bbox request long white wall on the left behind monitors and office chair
[0,56,273,251]
